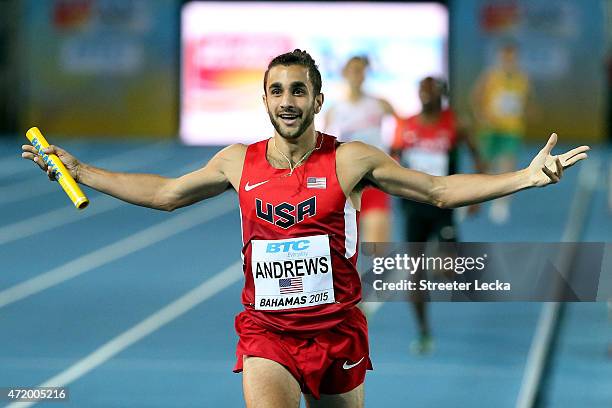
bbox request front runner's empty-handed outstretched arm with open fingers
[347,133,590,208]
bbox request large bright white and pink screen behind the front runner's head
[180,2,448,145]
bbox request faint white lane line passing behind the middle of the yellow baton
[0,142,172,204]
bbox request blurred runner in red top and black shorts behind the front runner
[391,77,484,354]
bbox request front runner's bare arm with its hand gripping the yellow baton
[21,145,245,211]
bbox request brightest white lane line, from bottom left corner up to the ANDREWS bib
[7,261,243,408]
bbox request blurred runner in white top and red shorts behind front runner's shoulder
[325,56,395,242]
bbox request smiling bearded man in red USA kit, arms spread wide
[22,50,589,408]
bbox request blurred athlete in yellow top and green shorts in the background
[472,43,533,224]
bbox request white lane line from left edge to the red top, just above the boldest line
[0,195,236,308]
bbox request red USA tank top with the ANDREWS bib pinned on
[238,133,361,335]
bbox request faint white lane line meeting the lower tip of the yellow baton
[0,160,202,245]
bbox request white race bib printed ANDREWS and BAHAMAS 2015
[251,235,335,310]
